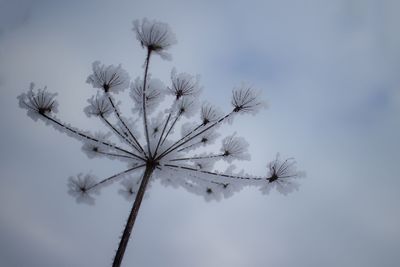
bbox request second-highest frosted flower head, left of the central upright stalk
[86,61,130,93]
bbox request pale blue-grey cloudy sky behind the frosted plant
[0,0,400,267]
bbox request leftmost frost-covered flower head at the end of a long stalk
[18,83,58,120]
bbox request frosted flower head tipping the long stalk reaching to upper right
[231,84,266,114]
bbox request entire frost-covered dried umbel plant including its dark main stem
[18,19,299,266]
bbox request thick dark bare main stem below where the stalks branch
[112,164,155,267]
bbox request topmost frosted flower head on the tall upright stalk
[133,18,176,59]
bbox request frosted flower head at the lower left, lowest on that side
[68,173,98,205]
